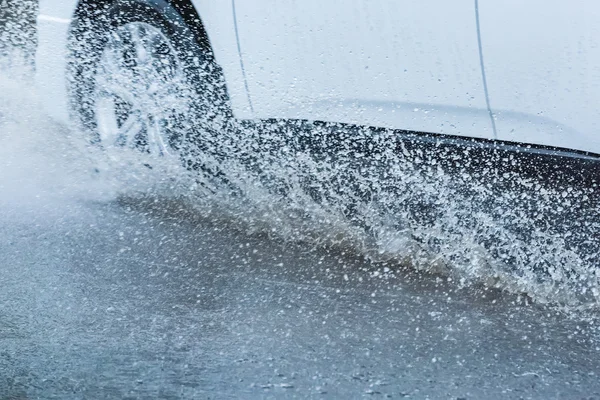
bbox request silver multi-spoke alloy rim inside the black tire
[94,22,190,158]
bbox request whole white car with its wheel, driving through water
[36,0,600,165]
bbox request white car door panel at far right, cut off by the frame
[479,0,600,153]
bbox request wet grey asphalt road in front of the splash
[0,185,600,399]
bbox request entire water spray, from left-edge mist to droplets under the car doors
[0,18,600,313]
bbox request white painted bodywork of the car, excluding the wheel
[36,0,600,155]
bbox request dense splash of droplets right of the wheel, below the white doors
[171,121,600,312]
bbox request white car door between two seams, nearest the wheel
[234,0,493,138]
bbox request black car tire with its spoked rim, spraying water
[68,0,233,170]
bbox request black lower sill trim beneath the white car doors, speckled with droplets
[243,119,600,188]
